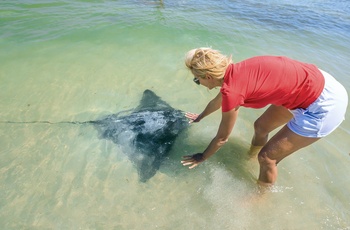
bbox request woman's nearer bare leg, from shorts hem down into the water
[258,126,320,185]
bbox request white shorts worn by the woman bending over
[287,70,348,138]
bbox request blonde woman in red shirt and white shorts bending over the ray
[181,48,348,185]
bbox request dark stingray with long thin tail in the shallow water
[1,90,189,182]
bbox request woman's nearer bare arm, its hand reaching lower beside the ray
[181,107,239,169]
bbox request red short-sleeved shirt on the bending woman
[220,56,325,112]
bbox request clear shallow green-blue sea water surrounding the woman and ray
[0,0,350,230]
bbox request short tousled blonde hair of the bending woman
[185,47,232,80]
